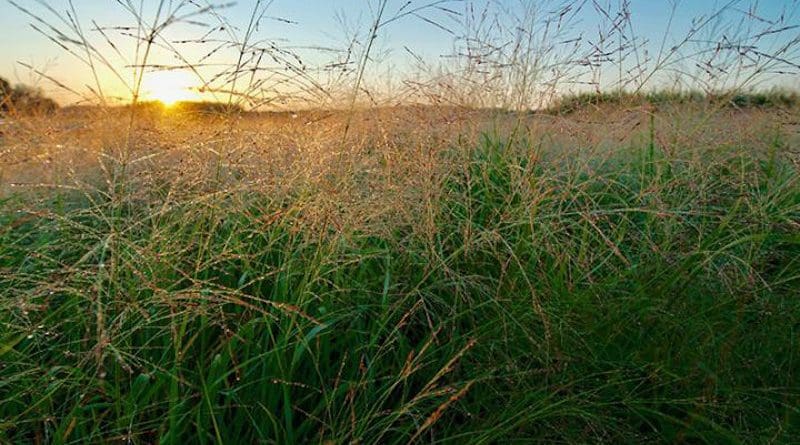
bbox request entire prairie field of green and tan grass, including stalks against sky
[0,0,800,445]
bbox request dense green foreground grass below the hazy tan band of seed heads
[0,116,800,444]
